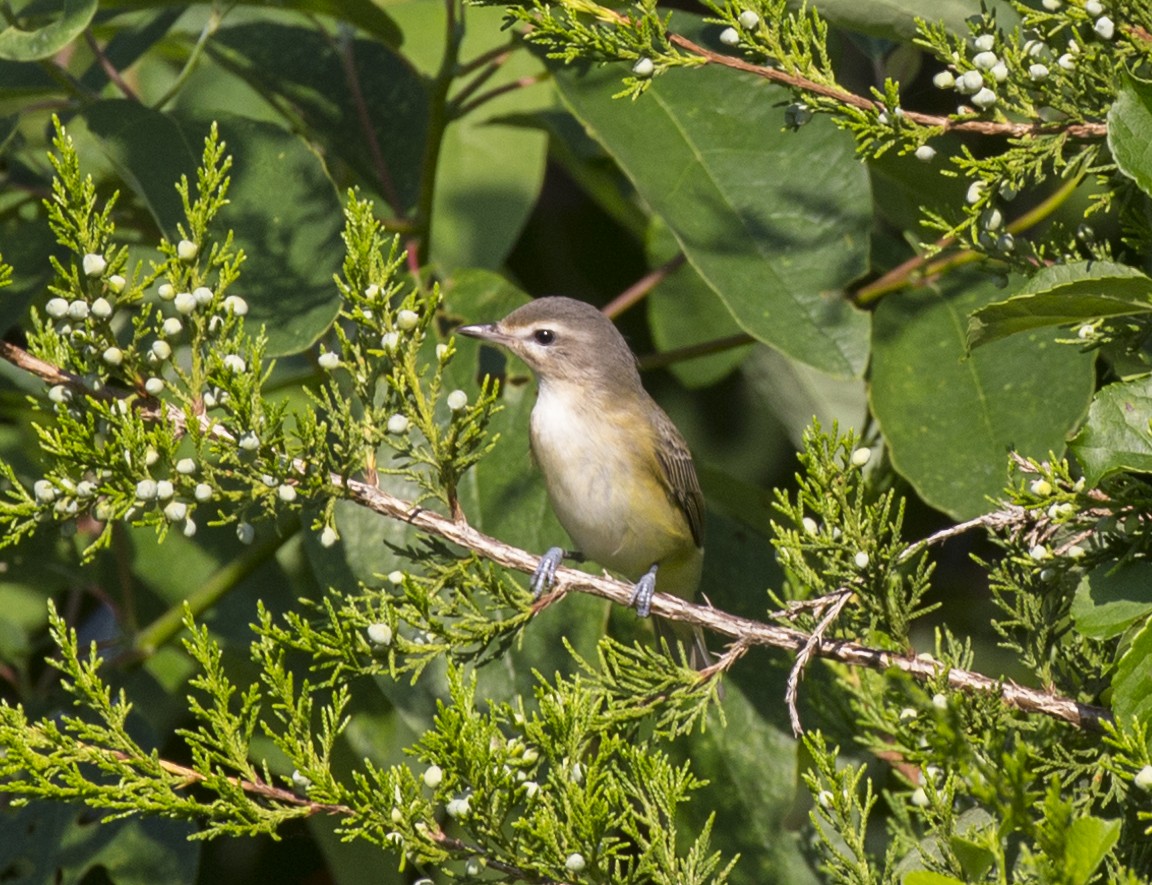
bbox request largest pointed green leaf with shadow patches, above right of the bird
[556,41,871,375]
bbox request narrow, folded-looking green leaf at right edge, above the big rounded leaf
[968,262,1152,347]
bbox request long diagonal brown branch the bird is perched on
[0,341,1112,728]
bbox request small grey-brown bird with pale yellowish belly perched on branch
[456,297,710,668]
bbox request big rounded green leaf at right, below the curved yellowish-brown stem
[870,274,1094,519]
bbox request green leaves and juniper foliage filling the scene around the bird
[0,0,1152,885]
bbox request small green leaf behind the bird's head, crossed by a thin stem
[646,219,749,387]
